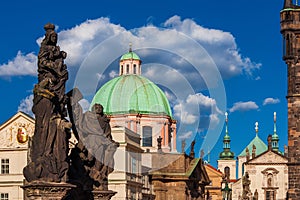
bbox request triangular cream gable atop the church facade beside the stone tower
[247,151,288,164]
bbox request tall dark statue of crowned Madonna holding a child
[23,23,71,182]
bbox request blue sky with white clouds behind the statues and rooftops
[0,0,287,165]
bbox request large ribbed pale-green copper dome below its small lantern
[91,75,172,117]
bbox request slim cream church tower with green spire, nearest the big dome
[218,112,236,179]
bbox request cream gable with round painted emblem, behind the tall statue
[0,112,34,149]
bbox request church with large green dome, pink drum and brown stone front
[91,47,210,200]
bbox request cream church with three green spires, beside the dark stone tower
[218,113,288,200]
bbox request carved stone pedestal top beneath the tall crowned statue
[22,181,76,200]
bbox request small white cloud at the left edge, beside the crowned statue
[0,51,37,76]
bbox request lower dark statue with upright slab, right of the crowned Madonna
[68,88,119,190]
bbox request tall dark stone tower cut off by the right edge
[280,0,300,199]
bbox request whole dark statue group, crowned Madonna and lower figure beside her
[23,23,119,200]
